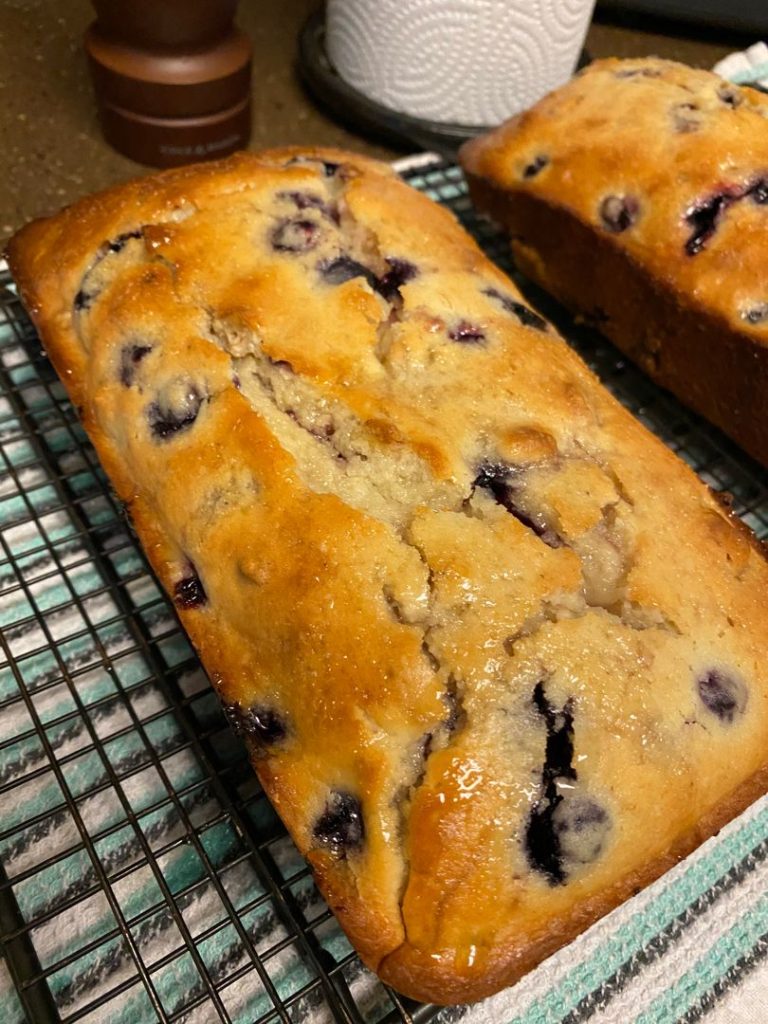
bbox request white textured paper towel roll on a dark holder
[326,0,595,126]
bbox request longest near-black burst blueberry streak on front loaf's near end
[525,682,577,886]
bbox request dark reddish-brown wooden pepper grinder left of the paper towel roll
[85,0,252,167]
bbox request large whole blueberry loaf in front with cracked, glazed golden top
[10,150,768,1002]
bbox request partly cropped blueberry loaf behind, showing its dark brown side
[462,59,768,465]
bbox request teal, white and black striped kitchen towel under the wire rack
[0,151,768,1024]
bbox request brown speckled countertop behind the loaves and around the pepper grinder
[0,0,743,245]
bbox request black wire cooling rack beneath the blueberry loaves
[0,155,768,1024]
